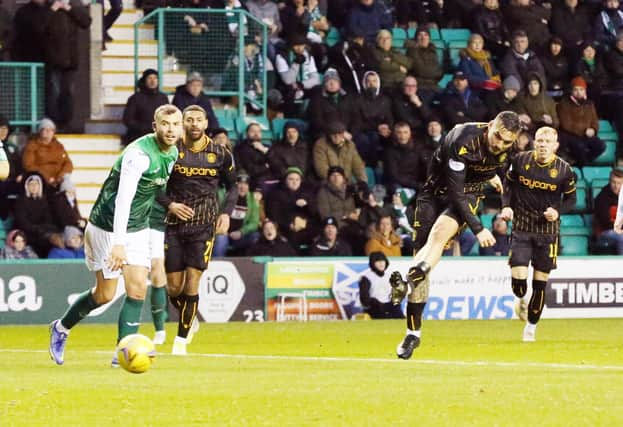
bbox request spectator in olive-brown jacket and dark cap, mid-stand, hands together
[313,121,368,182]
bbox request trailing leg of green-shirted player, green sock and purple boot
[49,223,121,365]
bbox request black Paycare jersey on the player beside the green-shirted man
[163,136,237,229]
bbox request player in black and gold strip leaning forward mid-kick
[390,111,520,359]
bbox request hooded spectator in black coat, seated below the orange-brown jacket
[13,174,64,257]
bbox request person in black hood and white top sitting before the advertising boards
[359,251,405,319]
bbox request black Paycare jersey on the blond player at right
[505,151,576,234]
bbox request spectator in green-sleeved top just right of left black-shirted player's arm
[212,170,260,258]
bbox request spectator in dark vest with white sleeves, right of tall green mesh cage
[275,34,320,117]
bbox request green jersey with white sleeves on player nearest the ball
[89,134,177,232]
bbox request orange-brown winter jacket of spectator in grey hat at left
[22,136,74,183]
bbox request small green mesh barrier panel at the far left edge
[0,62,44,131]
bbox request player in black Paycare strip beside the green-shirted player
[158,105,238,354]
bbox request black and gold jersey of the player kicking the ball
[424,123,509,234]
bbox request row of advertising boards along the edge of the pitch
[0,256,623,324]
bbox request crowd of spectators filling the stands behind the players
[0,0,623,257]
